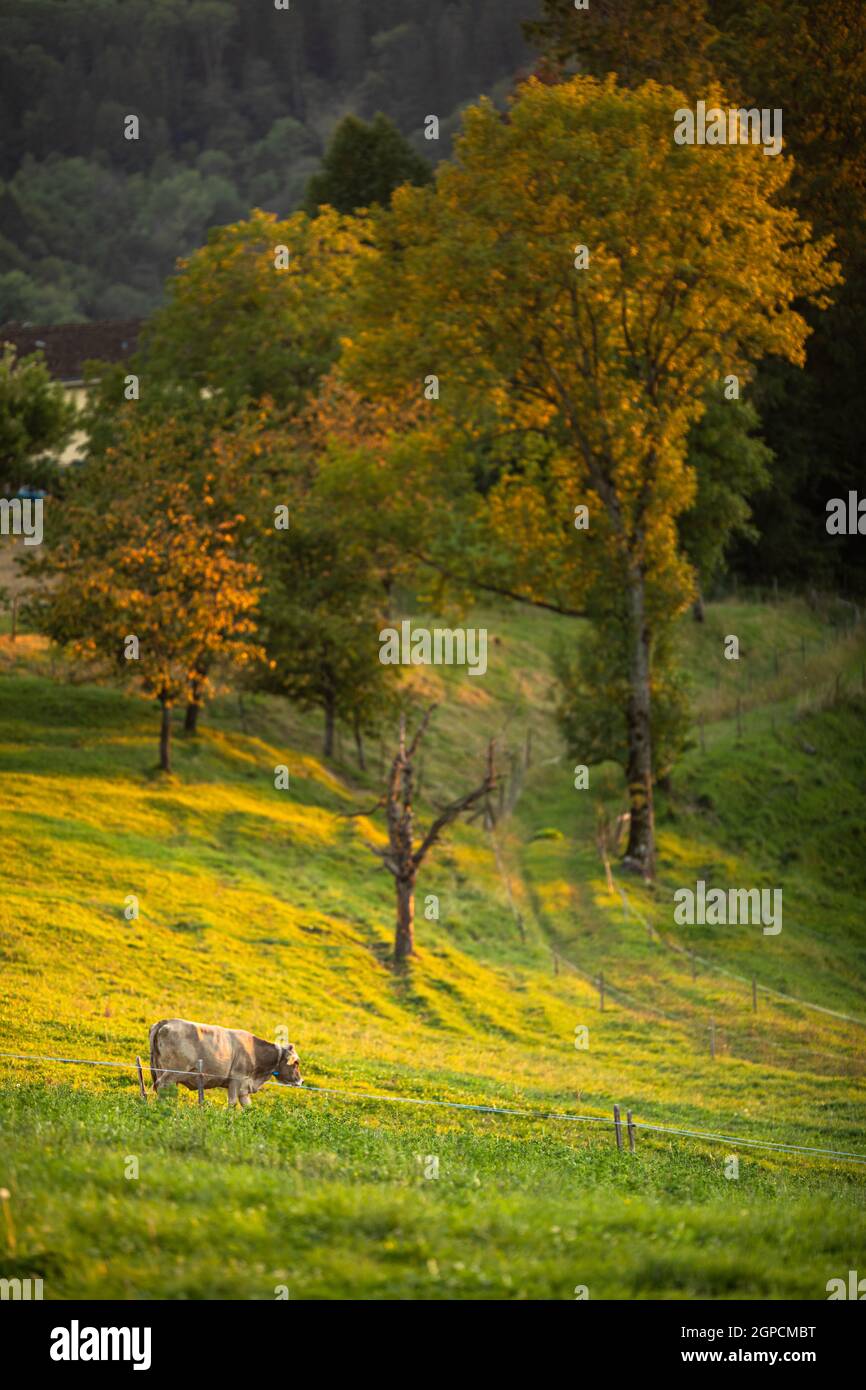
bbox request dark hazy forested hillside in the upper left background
[0,0,538,322]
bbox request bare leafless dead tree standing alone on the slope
[343,705,496,962]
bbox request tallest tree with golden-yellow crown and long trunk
[346,76,838,876]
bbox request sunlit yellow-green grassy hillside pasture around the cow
[0,600,866,1298]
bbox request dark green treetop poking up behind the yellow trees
[306,111,432,214]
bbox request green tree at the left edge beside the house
[0,343,75,491]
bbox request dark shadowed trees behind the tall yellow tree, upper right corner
[525,0,866,591]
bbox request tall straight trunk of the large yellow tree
[623,571,656,878]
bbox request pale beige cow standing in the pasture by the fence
[150,1019,303,1109]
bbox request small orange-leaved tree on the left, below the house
[31,421,263,771]
